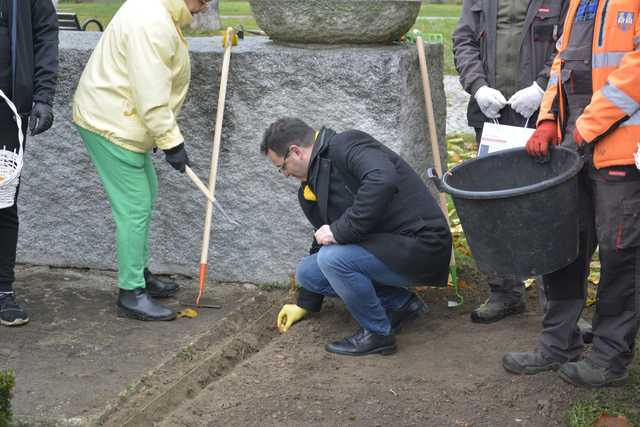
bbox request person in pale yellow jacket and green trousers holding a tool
[73,0,208,320]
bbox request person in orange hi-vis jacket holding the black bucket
[503,0,640,387]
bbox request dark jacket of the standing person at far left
[3,0,58,116]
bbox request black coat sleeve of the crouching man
[330,131,399,244]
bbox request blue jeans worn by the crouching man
[296,245,411,335]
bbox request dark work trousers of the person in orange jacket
[538,165,640,373]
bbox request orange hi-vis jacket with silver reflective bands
[538,0,640,169]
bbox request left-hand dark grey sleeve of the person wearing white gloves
[453,0,489,96]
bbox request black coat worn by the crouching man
[298,128,451,311]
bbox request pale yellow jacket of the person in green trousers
[73,0,192,152]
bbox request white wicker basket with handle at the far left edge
[0,90,24,209]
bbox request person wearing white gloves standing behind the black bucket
[452,0,570,323]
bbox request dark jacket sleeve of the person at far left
[31,0,58,105]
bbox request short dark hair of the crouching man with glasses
[260,117,313,157]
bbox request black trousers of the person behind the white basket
[0,118,27,292]
